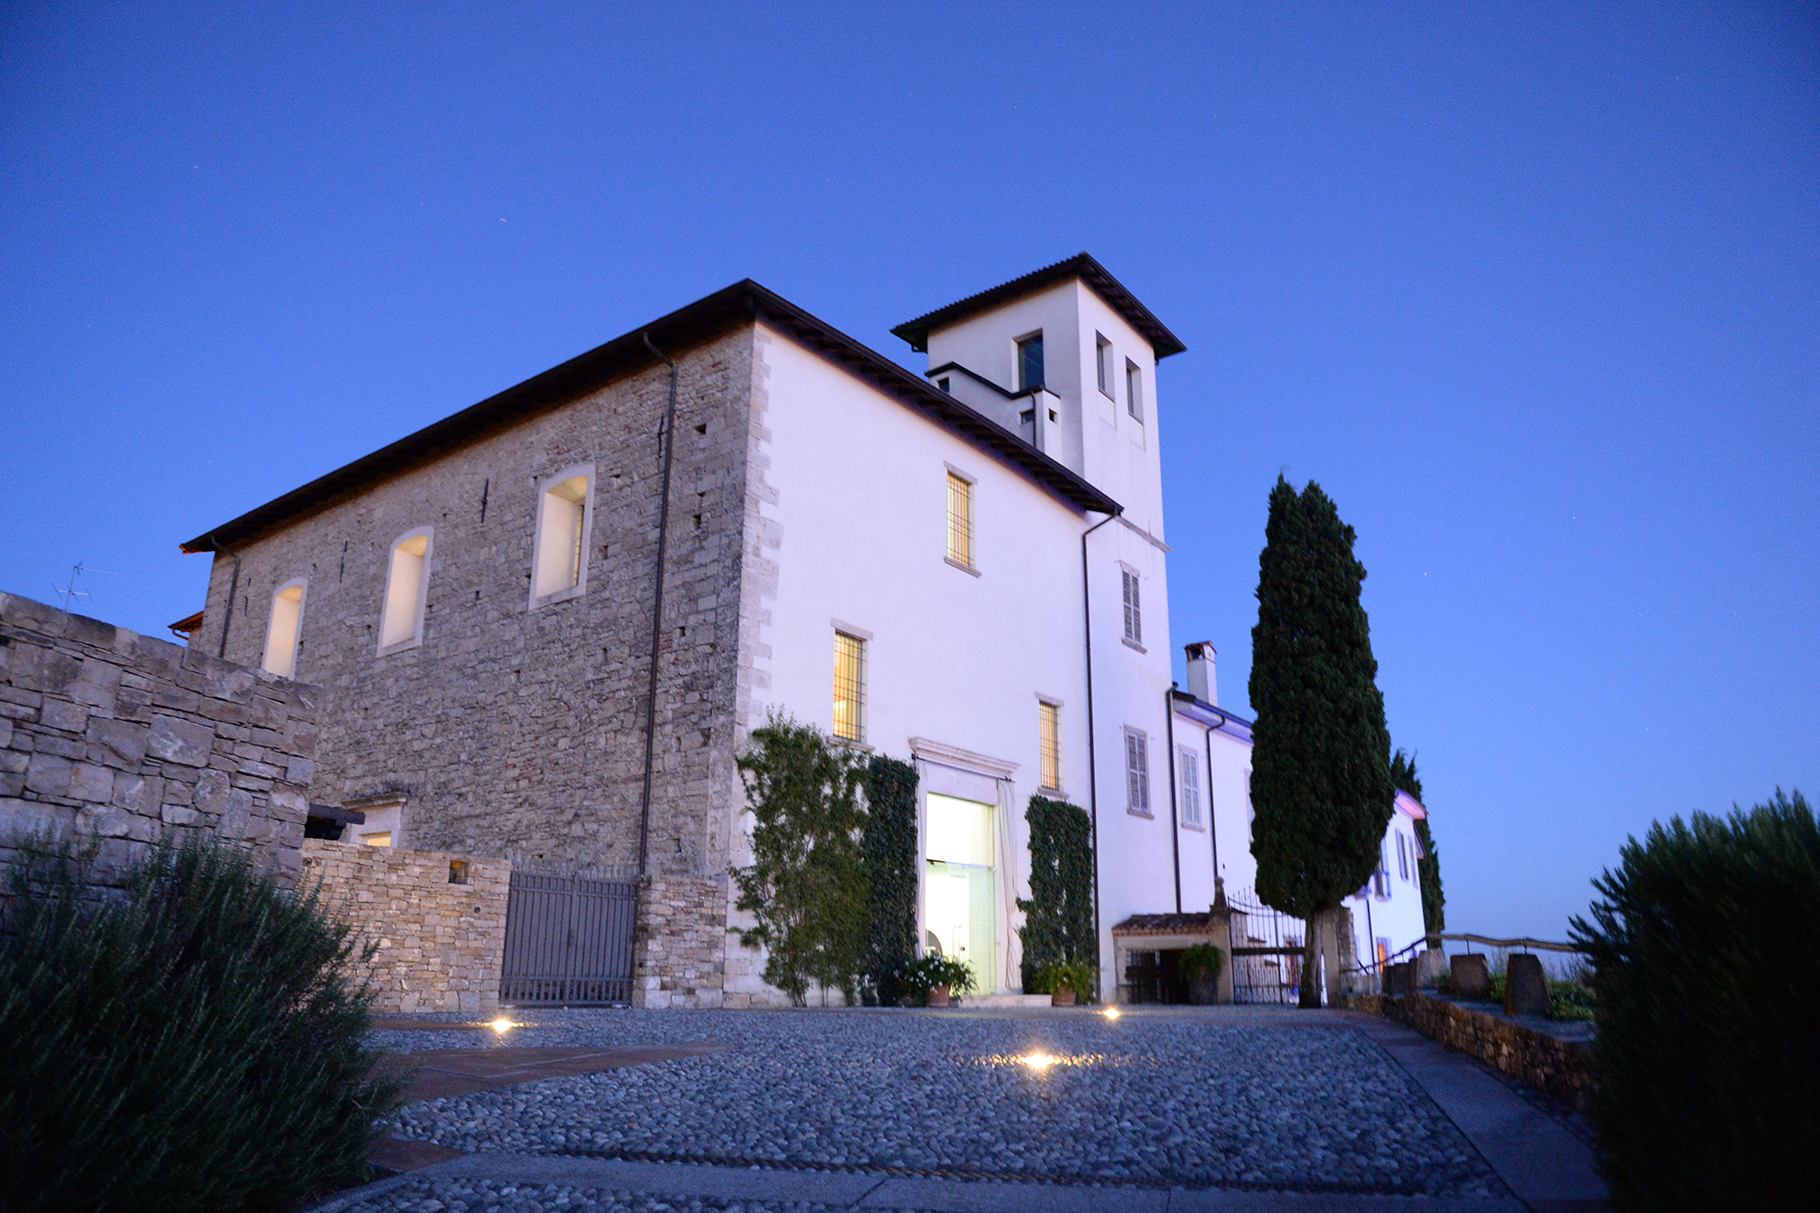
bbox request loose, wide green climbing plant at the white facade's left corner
[730,716,872,1007]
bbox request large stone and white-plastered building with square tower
[184,253,1245,1005]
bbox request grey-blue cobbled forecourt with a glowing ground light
[375,1011,1505,1208]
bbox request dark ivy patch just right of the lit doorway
[1017,796,1099,993]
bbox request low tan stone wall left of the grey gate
[302,838,511,1014]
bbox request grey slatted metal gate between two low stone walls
[499,863,639,1007]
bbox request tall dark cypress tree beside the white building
[1250,475,1396,1007]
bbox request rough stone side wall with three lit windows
[193,324,753,878]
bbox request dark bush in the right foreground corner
[1574,790,1820,1209]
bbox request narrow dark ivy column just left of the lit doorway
[859,754,917,1007]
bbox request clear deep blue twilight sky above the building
[0,2,1820,938]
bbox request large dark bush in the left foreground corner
[0,843,399,1213]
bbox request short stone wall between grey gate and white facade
[632,876,728,1011]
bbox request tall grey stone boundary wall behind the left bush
[0,594,319,887]
